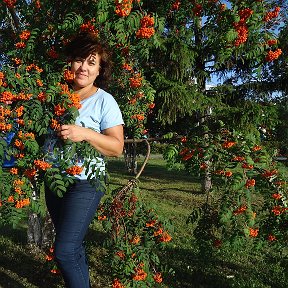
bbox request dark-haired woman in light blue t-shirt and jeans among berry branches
[45,33,124,288]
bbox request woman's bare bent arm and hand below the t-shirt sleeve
[58,125,124,157]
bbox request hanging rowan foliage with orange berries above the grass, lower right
[166,122,288,252]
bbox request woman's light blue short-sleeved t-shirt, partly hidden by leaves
[44,88,124,180]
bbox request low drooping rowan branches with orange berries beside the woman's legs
[98,181,172,287]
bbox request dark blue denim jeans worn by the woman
[45,180,104,288]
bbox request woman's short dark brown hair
[64,32,112,89]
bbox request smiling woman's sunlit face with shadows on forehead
[71,53,101,89]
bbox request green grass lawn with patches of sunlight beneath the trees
[0,156,288,288]
